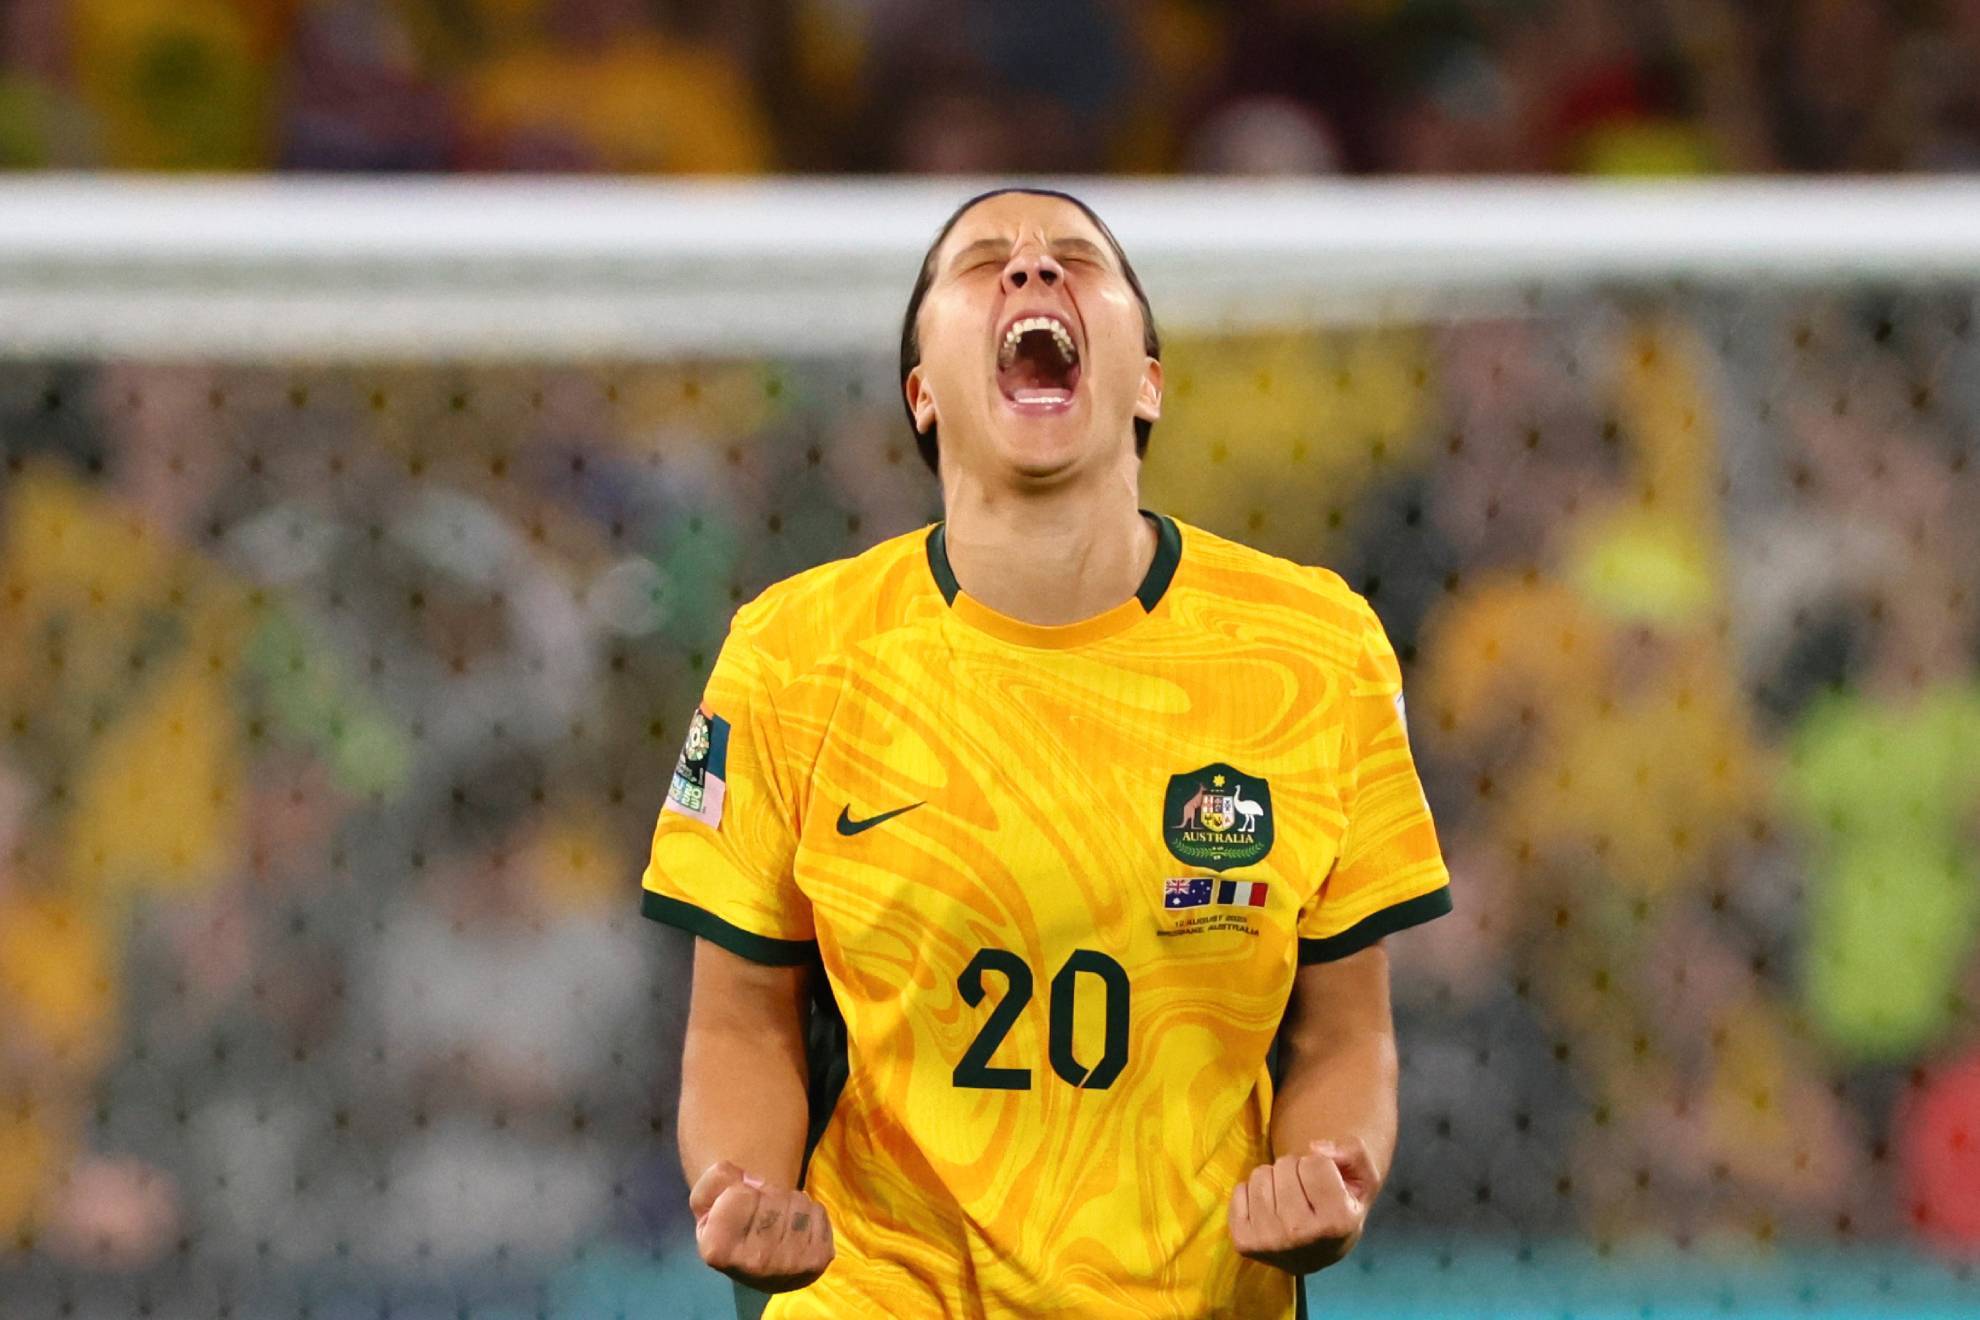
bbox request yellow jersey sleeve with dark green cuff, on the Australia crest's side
[1299,602,1451,962]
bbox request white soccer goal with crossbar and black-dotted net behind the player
[0,180,1980,1320]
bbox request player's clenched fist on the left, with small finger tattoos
[687,1160,832,1292]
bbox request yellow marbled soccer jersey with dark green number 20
[644,515,1451,1320]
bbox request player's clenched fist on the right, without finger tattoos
[1232,1142,1376,1274]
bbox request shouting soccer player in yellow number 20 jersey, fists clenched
[644,190,1449,1318]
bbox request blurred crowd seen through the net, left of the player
[0,362,933,1316]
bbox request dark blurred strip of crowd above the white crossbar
[0,0,1980,174]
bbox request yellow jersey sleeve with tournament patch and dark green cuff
[642,629,816,966]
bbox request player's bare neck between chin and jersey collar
[942,457,1156,625]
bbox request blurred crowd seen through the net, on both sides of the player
[0,287,1980,1316]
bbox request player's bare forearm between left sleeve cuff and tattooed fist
[679,944,808,1187]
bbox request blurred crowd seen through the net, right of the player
[1146,291,1980,1259]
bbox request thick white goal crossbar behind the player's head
[0,174,1980,360]
